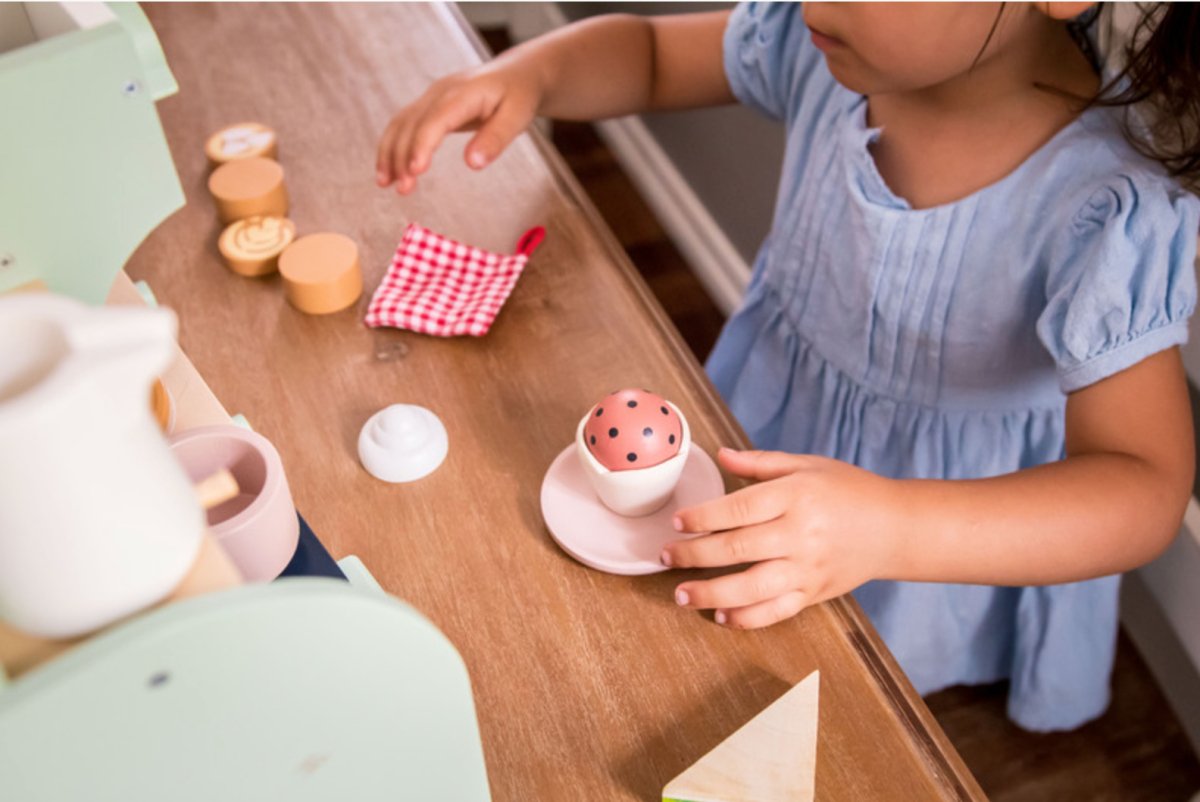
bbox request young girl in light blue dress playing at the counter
[378,2,1200,730]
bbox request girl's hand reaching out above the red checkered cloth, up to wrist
[376,56,542,194]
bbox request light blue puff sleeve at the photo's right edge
[1037,174,1200,393]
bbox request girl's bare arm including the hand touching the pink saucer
[664,348,1195,627]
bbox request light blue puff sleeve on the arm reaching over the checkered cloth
[724,2,833,120]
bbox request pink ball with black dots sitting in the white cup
[583,390,683,471]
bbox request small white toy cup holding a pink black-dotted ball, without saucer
[575,389,691,517]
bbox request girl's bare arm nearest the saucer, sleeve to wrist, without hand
[895,348,1195,585]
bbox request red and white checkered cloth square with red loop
[366,223,546,337]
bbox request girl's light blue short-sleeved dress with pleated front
[708,4,1200,730]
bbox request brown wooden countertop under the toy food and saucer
[127,4,982,801]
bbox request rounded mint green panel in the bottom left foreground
[0,571,490,802]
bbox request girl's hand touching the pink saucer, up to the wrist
[662,449,904,629]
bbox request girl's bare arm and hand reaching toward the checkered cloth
[376,11,733,193]
